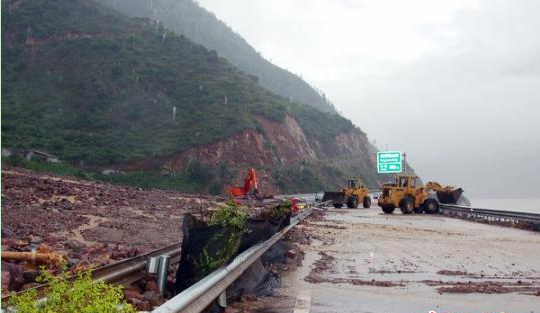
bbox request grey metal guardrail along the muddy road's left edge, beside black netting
[152,210,311,313]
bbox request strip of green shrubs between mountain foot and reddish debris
[2,155,376,195]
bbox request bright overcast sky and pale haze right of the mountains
[199,0,540,199]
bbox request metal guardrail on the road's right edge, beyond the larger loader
[439,204,540,231]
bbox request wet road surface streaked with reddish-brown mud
[269,206,540,313]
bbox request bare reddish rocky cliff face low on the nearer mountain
[119,115,378,194]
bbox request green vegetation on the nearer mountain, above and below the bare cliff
[1,0,380,193]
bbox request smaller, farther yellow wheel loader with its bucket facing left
[322,179,371,209]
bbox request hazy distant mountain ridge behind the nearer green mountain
[95,0,336,113]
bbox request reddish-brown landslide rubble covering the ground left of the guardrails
[2,166,279,298]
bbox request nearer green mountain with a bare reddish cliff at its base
[1,0,388,193]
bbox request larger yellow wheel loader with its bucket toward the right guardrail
[378,175,463,214]
